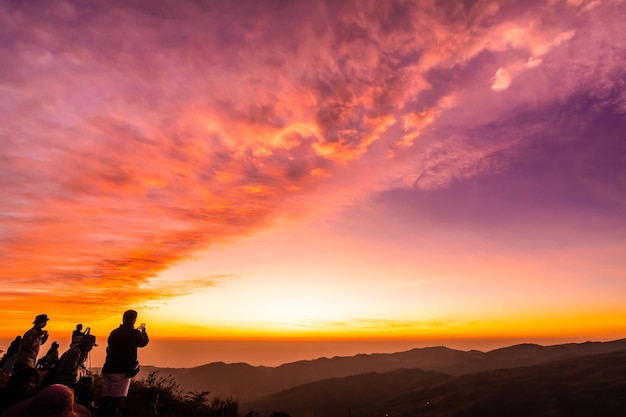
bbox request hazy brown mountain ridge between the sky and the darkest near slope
[140,339,626,398]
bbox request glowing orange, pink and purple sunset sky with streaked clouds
[0,0,626,366]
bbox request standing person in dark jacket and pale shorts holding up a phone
[98,310,149,417]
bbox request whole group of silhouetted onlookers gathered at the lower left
[0,310,149,417]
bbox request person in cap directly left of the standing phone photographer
[55,335,98,410]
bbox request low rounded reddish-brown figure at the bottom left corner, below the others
[2,384,89,417]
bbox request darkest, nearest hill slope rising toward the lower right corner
[241,351,626,417]
